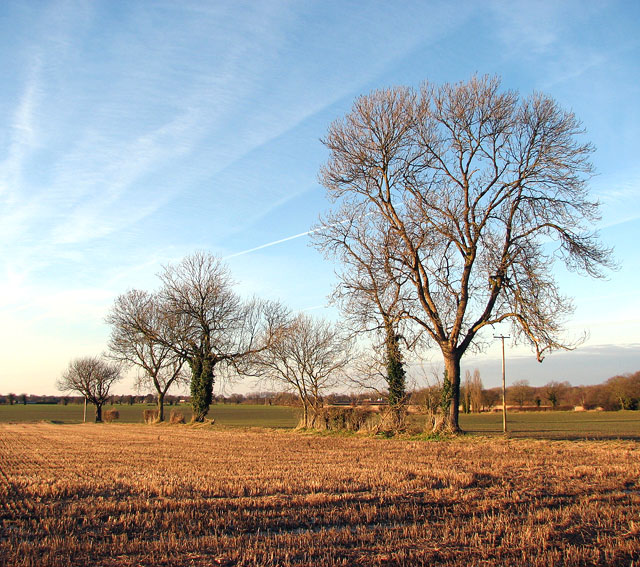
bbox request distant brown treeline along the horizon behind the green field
[0,371,640,412]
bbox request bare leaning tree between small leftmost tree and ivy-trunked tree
[106,290,188,421]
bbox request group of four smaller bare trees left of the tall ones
[58,252,352,427]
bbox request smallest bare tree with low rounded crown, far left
[56,356,122,423]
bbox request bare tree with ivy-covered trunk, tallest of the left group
[158,252,282,421]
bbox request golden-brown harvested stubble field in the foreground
[0,424,640,566]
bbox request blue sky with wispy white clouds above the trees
[0,0,640,393]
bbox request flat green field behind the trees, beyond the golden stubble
[0,404,640,440]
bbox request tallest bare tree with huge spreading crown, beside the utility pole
[317,77,611,431]
